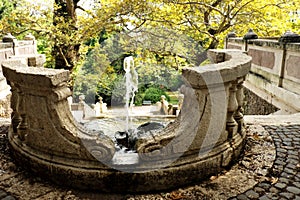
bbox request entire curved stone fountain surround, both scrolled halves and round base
[2,50,251,192]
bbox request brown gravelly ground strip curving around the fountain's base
[0,121,276,200]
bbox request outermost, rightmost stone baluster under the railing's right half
[234,78,245,133]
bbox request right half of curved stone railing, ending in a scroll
[137,50,251,166]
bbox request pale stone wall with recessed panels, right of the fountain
[225,34,300,113]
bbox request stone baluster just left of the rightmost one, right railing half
[226,82,238,139]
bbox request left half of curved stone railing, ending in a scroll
[2,61,115,173]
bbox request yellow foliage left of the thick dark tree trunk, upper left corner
[0,0,54,67]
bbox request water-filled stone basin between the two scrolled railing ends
[82,116,175,165]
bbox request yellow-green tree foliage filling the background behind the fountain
[0,0,300,104]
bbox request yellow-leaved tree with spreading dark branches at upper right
[122,0,298,64]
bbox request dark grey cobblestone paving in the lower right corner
[231,125,300,200]
